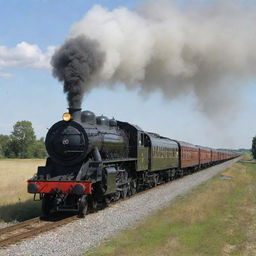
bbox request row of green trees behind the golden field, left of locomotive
[0,121,47,158]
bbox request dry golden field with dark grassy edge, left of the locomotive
[0,159,45,222]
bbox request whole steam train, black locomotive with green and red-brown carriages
[27,108,239,217]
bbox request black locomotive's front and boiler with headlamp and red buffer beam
[28,109,129,215]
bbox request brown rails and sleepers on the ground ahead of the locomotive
[0,216,78,248]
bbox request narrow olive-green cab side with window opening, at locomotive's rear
[137,132,149,171]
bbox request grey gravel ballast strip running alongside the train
[0,159,237,256]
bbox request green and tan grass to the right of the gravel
[86,155,256,256]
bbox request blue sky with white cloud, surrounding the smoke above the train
[0,0,256,148]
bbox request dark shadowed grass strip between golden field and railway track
[0,199,41,222]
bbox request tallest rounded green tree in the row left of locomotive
[9,121,36,158]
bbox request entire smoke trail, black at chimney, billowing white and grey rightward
[52,0,256,118]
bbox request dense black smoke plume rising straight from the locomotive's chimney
[51,36,105,108]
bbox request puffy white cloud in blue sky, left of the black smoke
[0,42,55,78]
